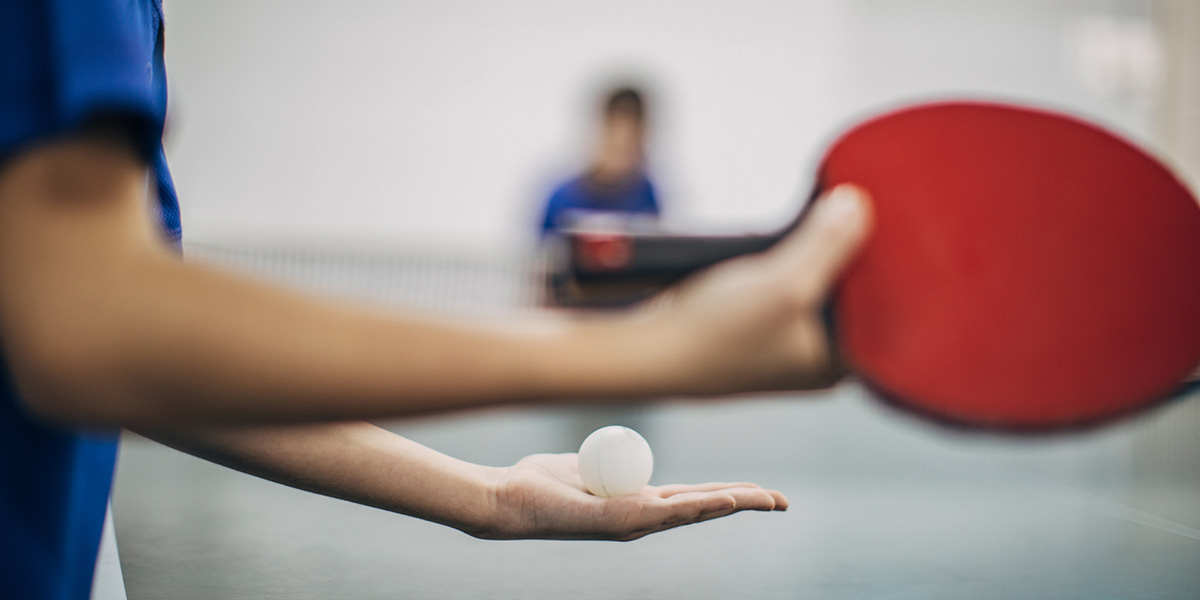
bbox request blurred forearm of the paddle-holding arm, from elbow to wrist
[79,250,681,422]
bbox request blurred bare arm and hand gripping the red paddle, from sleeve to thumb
[0,137,868,427]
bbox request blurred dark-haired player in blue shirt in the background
[541,88,660,238]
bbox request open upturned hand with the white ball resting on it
[472,454,787,541]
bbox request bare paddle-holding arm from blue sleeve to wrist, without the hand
[0,139,686,426]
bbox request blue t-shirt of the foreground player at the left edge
[0,0,180,600]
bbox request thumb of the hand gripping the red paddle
[772,184,872,301]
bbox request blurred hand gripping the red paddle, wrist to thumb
[642,185,871,395]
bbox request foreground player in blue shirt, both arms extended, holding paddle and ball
[0,0,870,600]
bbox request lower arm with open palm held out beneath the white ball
[144,422,787,540]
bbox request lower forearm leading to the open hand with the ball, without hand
[139,421,500,535]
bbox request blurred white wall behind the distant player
[159,0,1152,247]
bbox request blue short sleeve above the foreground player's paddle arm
[0,0,167,163]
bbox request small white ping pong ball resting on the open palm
[580,425,654,498]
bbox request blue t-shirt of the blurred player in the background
[541,173,659,236]
